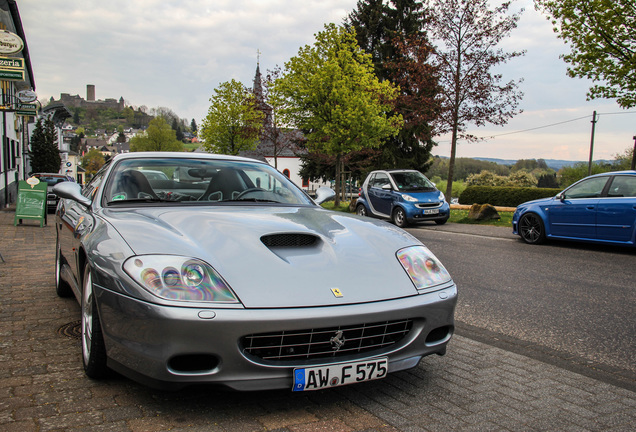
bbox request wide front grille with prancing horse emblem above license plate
[241,319,413,362]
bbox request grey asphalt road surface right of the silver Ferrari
[410,224,636,390]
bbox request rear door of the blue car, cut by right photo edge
[596,175,636,242]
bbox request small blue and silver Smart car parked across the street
[356,170,450,228]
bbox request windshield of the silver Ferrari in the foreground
[104,157,312,205]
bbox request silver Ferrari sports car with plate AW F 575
[54,153,457,391]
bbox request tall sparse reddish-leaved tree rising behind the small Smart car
[426,0,525,199]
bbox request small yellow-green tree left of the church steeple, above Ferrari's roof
[199,80,265,155]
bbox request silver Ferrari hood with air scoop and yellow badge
[104,206,428,308]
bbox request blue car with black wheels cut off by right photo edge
[512,171,636,246]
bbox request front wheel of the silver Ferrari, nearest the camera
[82,264,108,379]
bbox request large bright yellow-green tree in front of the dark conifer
[272,24,402,205]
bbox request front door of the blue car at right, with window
[547,176,609,239]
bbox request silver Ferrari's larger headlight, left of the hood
[124,255,239,303]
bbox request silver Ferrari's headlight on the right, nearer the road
[397,246,451,290]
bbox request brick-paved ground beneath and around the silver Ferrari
[0,211,636,432]
